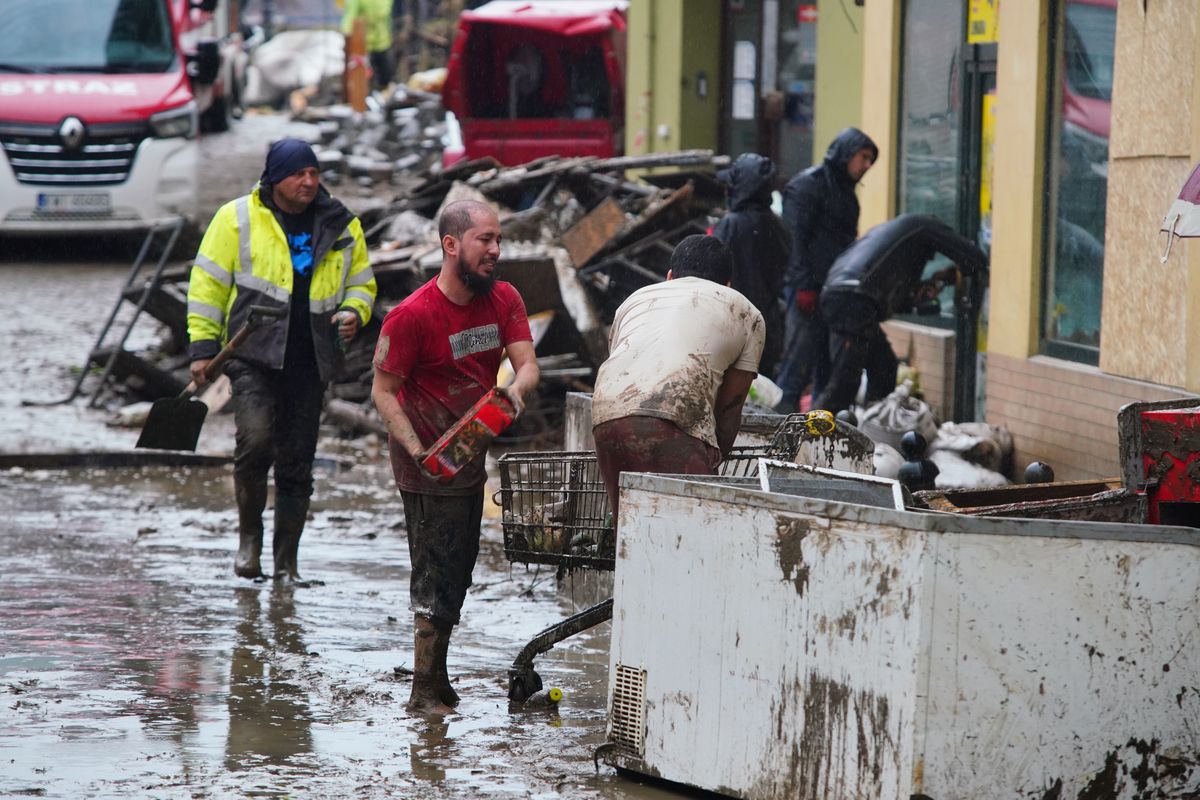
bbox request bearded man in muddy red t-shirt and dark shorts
[371,200,538,714]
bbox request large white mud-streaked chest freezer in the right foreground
[604,470,1200,800]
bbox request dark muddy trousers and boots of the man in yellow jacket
[226,360,325,579]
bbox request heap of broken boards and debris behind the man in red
[319,142,727,437]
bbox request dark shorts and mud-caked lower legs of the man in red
[400,489,484,714]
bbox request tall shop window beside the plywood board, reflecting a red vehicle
[1042,0,1117,363]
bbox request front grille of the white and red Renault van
[0,122,150,186]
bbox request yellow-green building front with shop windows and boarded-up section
[629,0,1200,479]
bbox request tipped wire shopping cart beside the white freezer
[498,443,768,703]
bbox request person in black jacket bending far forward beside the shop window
[812,213,988,414]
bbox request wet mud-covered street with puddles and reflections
[0,116,674,798]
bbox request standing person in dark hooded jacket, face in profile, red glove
[776,128,880,414]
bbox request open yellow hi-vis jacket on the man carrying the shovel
[187,187,376,380]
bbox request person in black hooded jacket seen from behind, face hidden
[713,152,791,378]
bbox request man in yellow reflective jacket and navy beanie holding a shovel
[187,139,376,581]
